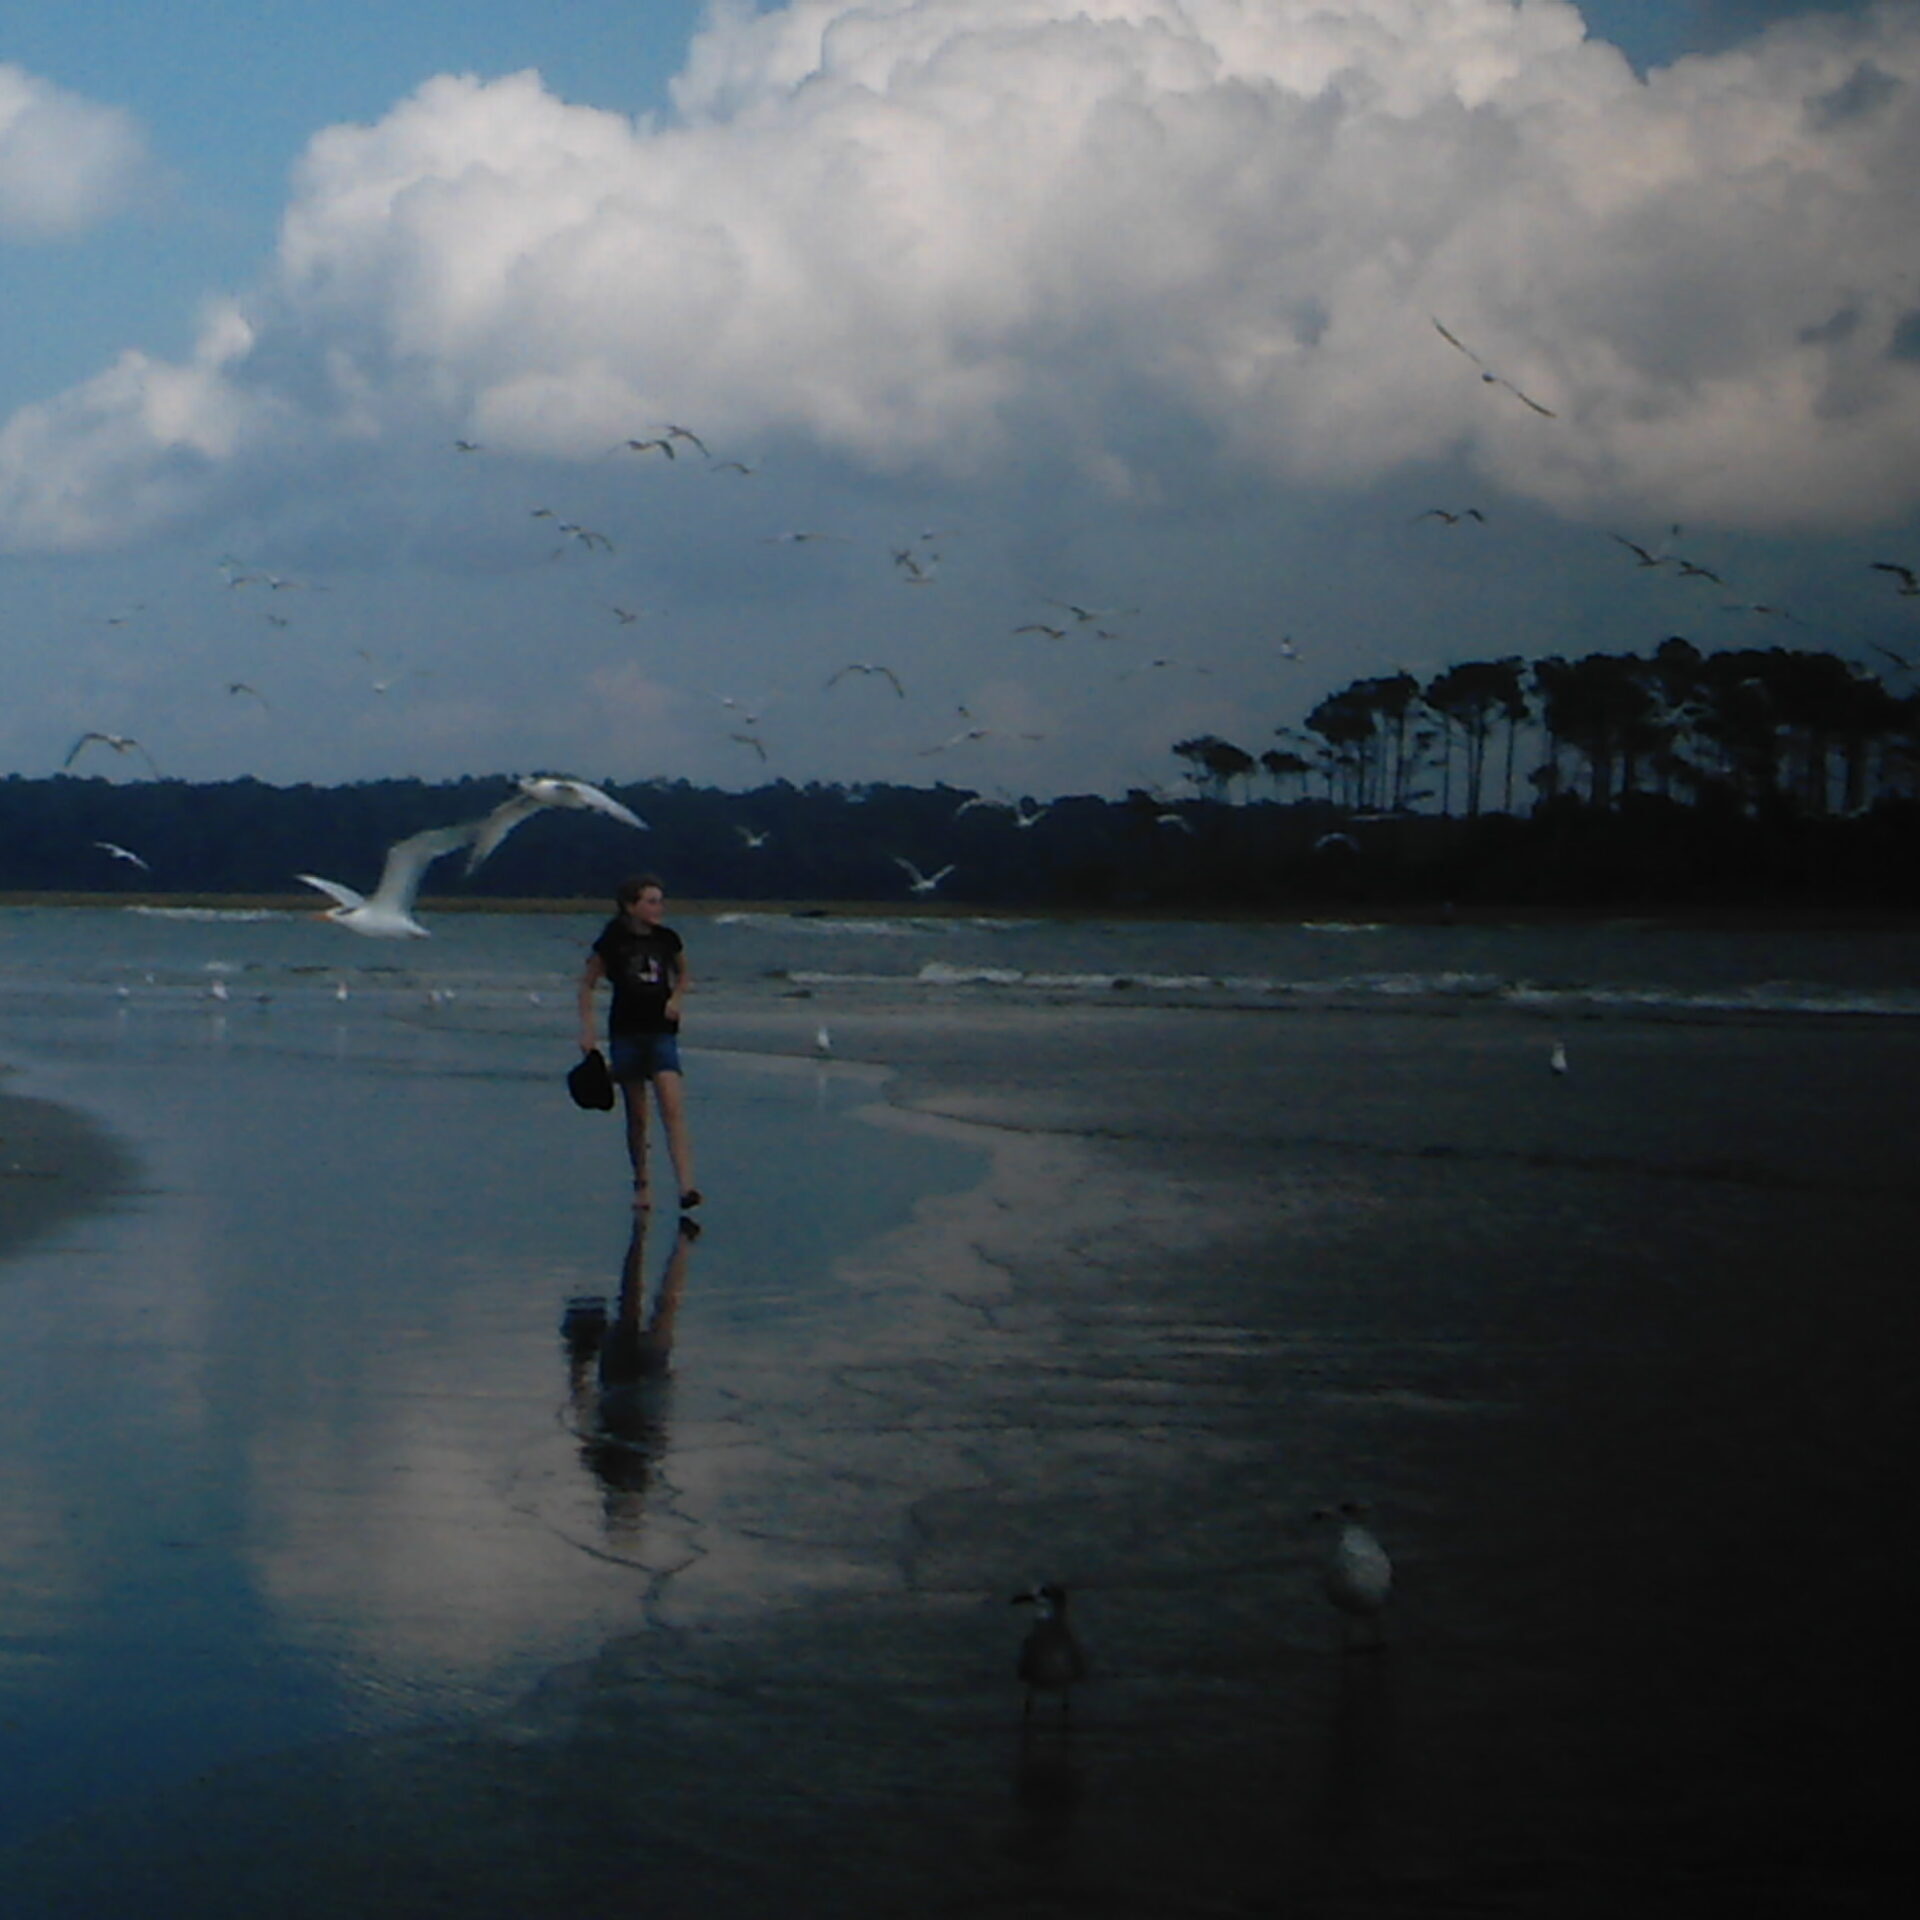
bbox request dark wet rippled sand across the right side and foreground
[0,917,1920,1920]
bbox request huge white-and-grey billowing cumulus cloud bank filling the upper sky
[0,0,1920,543]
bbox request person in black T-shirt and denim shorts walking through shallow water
[580,874,701,1213]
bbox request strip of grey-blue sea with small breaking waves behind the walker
[0,908,1920,1031]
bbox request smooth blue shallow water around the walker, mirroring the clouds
[0,916,977,1841]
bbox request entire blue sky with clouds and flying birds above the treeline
[0,0,1920,797]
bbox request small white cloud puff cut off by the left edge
[0,61,146,240]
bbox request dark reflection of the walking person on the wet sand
[561,1213,701,1534]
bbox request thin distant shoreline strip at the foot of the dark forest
[0,891,1920,933]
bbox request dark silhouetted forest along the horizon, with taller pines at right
[15,637,1920,912]
